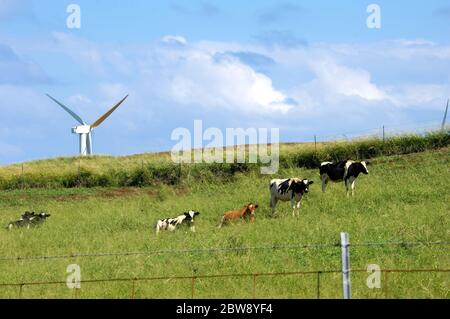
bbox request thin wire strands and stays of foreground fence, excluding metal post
[0,241,450,299]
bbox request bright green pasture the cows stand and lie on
[0,147,450,298]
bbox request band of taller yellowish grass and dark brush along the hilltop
[0,131,450,190]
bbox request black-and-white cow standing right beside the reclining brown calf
[269,178,314,216]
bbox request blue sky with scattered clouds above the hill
[0,0,450,164]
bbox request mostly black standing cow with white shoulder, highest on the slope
[320,160,369,196]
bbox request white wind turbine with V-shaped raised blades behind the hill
[47,94,128,156]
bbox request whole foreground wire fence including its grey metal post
[0,238,450,299]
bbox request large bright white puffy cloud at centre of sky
[170,52,292,113]
